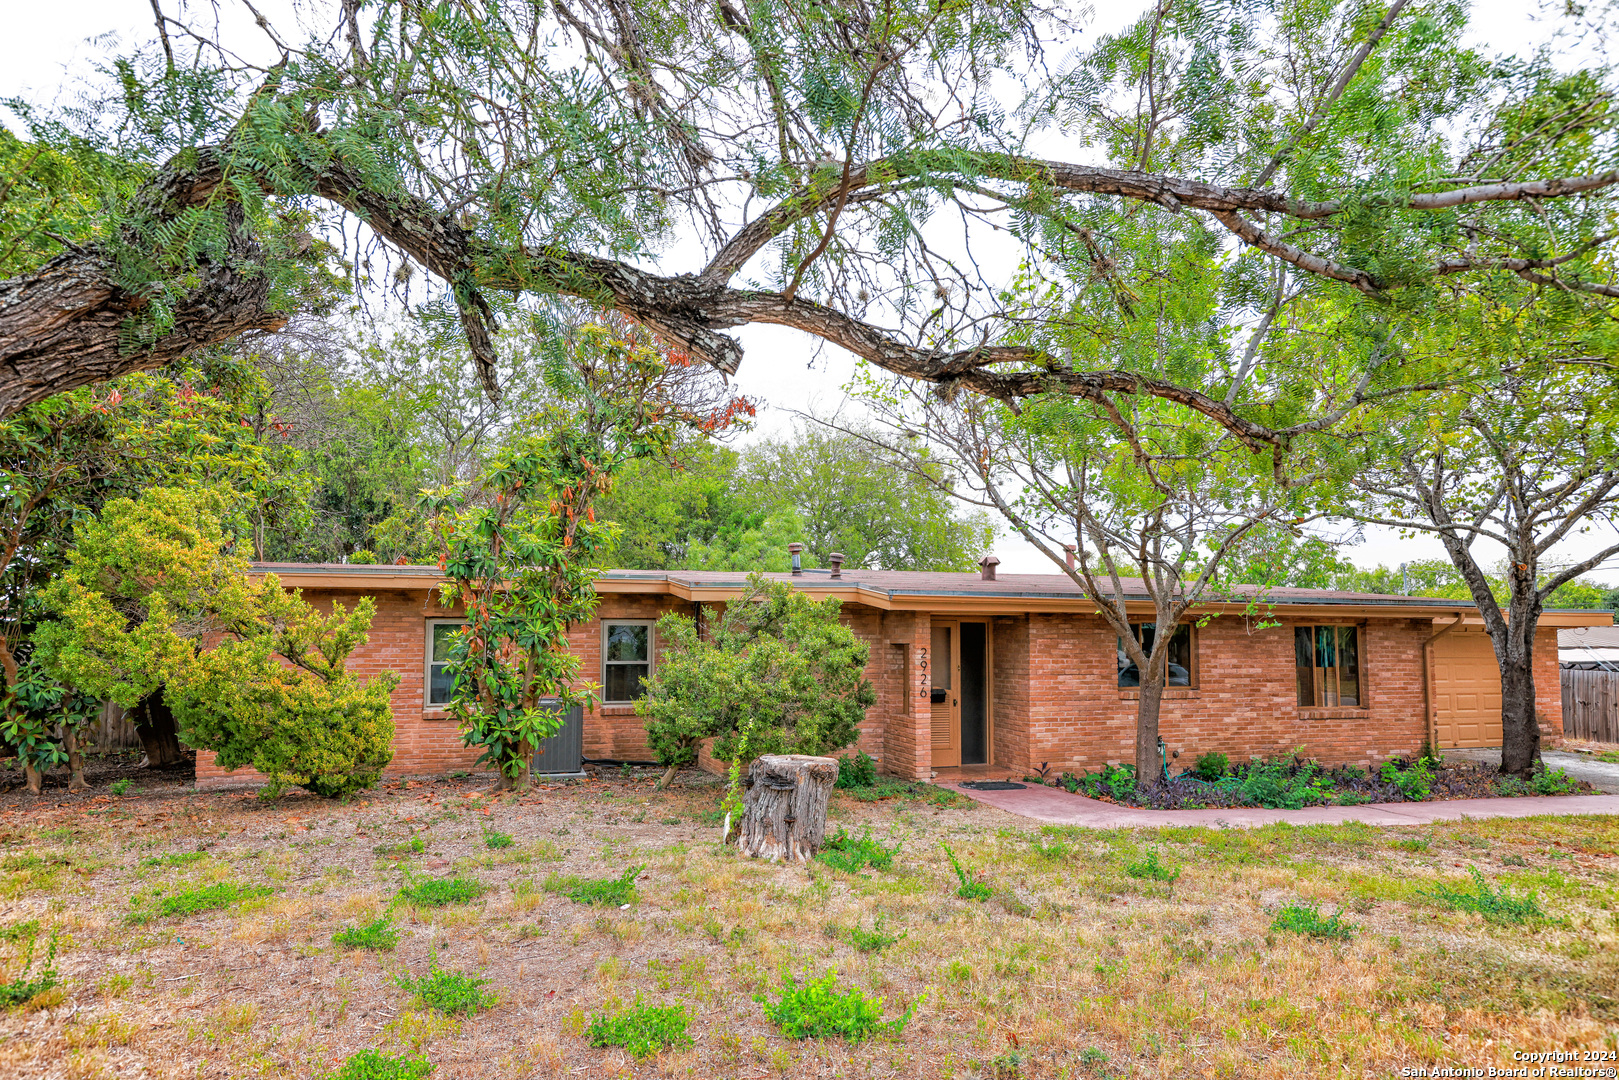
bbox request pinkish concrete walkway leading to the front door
[952,784,1619,829]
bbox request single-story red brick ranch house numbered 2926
[196,559,1609,787]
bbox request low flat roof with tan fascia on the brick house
[254,562,1608,627]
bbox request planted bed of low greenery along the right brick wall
[1023,755,1596,810]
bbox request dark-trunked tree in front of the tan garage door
[1349,359,1619,777]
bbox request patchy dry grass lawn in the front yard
[0,774,1619,1080]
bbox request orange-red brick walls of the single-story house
[198,589,1562,787]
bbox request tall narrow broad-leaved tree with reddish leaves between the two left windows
[423,321,753,789]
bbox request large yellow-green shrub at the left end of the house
[36,487,398,798]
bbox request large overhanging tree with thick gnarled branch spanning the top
[0,0,1619,450]
